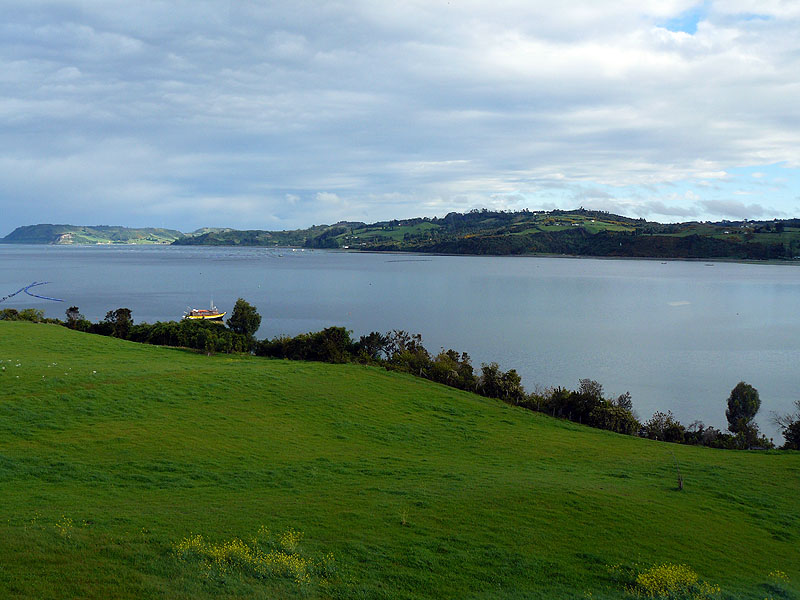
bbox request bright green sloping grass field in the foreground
[0,322,800,600]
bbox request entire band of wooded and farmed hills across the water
[0,208,800,262]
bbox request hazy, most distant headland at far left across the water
[0,224,183,245]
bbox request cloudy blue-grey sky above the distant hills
[0,0,800,236]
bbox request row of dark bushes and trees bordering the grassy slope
[0,298,800,450]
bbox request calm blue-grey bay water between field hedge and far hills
[0,245,800,440]
